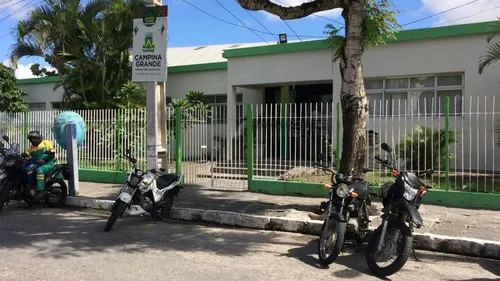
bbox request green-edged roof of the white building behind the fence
[18,22,500,85]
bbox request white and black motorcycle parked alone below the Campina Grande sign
[104,149,183,231]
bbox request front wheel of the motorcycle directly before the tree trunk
[318,214,346,265]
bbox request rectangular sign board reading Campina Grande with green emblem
[132,6,168,82]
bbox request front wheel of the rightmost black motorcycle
[366,221,413,277]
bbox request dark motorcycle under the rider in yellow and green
[0,135,69,211]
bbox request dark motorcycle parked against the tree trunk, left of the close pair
[316,164,371,265]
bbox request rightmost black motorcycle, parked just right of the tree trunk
[366,143,433,277]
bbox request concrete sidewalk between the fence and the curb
[76,182,500,241]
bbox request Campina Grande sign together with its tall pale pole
[132,0,168,169]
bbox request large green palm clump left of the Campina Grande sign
[11,0,144,109]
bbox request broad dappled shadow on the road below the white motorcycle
[0,205,305,259]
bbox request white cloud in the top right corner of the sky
[421,0,500,26]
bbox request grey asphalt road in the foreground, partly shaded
[0,203,500,281]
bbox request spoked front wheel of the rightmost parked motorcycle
[366,221,413,277]
